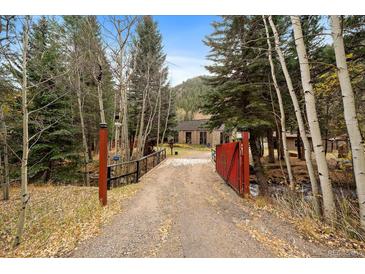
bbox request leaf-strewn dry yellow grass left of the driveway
[0,184,139,257]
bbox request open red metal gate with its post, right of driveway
[215,132,250,196]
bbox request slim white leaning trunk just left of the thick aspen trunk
[269,16,321,215]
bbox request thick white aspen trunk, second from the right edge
[291,16,336,222]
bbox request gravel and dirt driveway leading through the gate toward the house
[70,151,361,258]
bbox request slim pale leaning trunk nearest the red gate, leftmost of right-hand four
[262,16,295,190]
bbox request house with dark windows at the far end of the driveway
[177,119,228,147]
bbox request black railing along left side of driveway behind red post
[107,148,166,190]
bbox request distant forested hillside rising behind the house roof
[173,76,212,121]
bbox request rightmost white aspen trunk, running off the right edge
[331,15,365,229]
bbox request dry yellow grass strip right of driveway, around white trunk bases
[258,193,365,252]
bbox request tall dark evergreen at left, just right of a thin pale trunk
[28,17,79,181]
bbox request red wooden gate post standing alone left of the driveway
[99,123,108,206]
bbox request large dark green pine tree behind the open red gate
[203,16,273,194]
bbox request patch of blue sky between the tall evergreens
[153,15,219,86]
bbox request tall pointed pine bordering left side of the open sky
[128,16,169,157]
